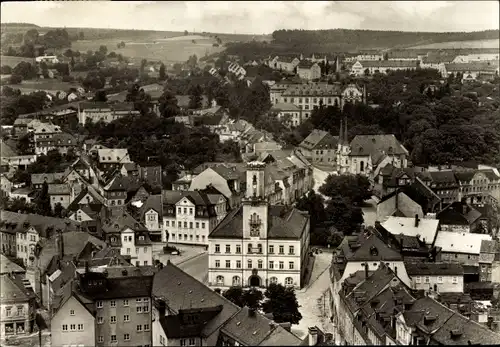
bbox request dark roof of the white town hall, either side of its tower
[209,206,309,239]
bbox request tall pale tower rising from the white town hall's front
[242,161,268,239]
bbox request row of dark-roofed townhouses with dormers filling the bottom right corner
[334,264,500,345]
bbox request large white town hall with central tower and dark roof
[208,162,310,288]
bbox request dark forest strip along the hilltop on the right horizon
[272,29,499,52]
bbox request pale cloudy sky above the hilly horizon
[0,1,500,34]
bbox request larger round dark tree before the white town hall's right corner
[262,283,302,324]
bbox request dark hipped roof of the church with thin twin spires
[350,134,408,157]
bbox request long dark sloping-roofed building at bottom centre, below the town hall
[152,261,302,346]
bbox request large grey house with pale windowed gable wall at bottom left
[51,267,154,346]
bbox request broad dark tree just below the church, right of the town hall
[319,175,372,206]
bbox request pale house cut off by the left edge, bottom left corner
[0,273,36,341]
